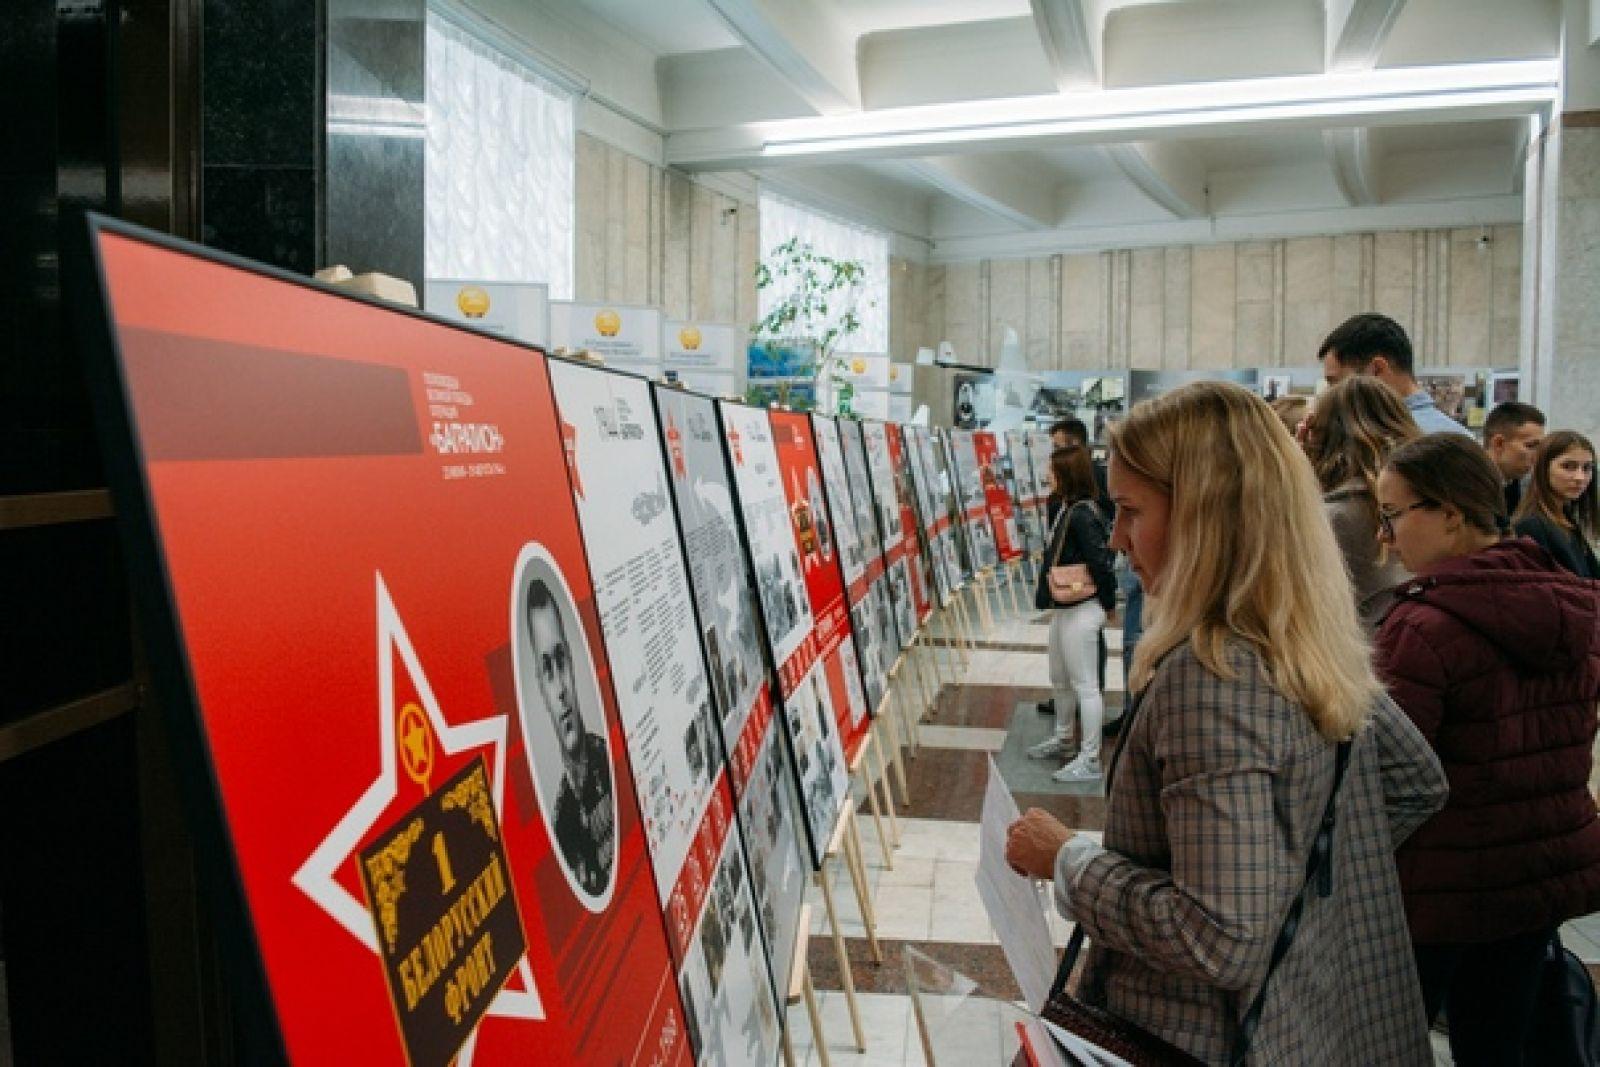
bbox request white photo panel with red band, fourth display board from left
[717,402,864,867]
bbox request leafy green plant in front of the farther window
[747,237,874,414]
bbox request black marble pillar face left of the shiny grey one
[200,0,323,274]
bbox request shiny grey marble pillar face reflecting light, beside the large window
[323,0,427,287]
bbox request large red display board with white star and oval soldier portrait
[74,221,693,1067]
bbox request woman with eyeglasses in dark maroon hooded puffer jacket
[1376,434,1600,1064]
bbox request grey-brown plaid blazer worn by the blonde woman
[1064,645,1446,1067]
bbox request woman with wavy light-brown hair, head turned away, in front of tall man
[1304,378,1422,635]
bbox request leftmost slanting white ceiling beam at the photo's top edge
[707,0,861,115]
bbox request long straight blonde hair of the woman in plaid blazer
[1110,382,1382,741]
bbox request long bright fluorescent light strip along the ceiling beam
[758,59,1560,157]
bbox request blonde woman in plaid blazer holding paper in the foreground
[1006,382,1446,1067]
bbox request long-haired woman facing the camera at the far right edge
[1515,430,1600,577]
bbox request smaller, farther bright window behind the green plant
[760,192,890,352]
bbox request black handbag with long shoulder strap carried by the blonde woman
[1040,687,1350,1067]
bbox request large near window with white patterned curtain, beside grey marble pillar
[424,11,576,301]
